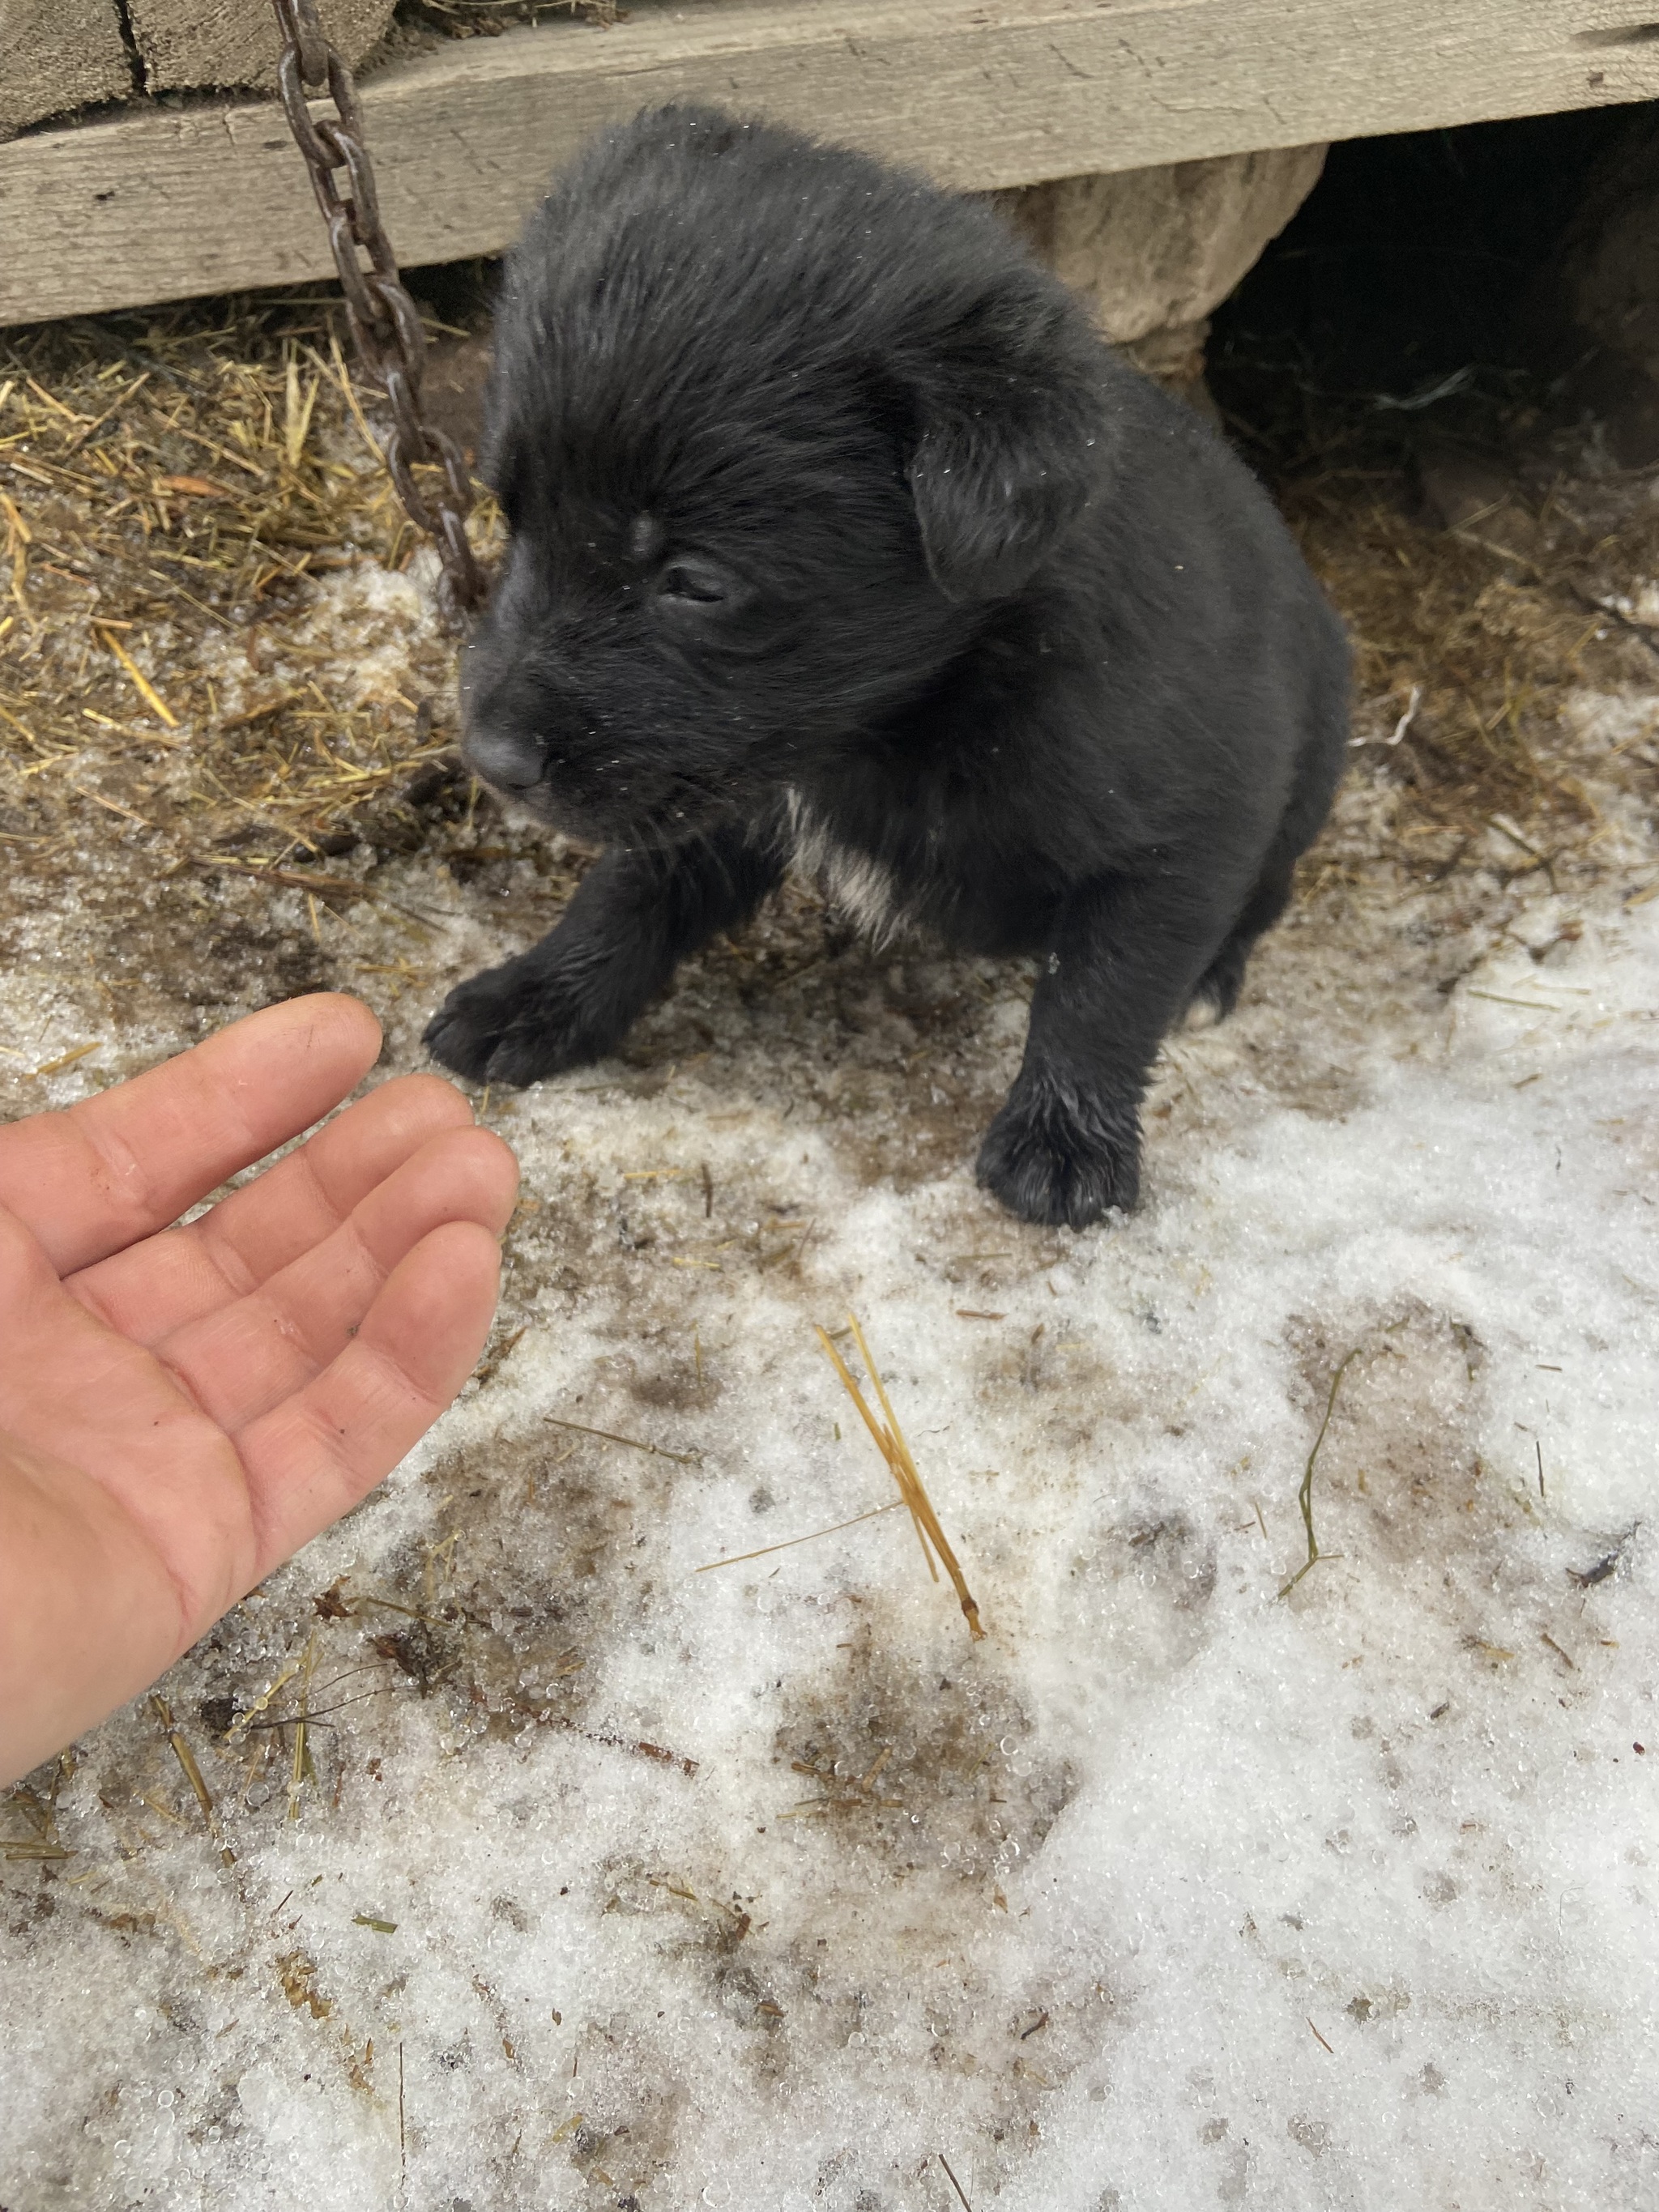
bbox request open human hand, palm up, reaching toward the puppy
[0,995,518,1780]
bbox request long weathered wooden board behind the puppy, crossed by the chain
[0,0,1659,323]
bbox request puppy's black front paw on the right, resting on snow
[978,1075,1141,1230]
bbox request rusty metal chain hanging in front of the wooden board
[272,0,488,624]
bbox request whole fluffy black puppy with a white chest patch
[427,109,1347,1225]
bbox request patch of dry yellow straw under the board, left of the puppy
[0,300,493,872]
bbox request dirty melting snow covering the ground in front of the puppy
[0,566,1659,2212]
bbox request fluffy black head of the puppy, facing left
[463,109,1102,843]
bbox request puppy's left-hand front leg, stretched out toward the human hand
[424,823,783,1084]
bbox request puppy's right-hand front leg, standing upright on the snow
[978,876,1226,1228]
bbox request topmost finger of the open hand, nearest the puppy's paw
[0,991,381,1274]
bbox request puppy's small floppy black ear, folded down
[909,296,1102,602]
